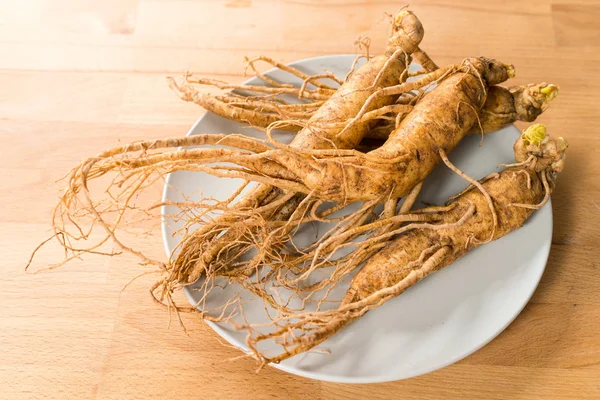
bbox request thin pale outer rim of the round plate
[160,53,554,384]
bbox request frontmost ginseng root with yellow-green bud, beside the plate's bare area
[247,125,567,365]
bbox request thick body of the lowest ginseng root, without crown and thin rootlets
[344,168,544,304]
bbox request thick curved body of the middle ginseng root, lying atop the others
[271,58,512,202]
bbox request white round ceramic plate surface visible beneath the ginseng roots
[163,55,552,383]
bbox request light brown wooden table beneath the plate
[0,0,600,399]
